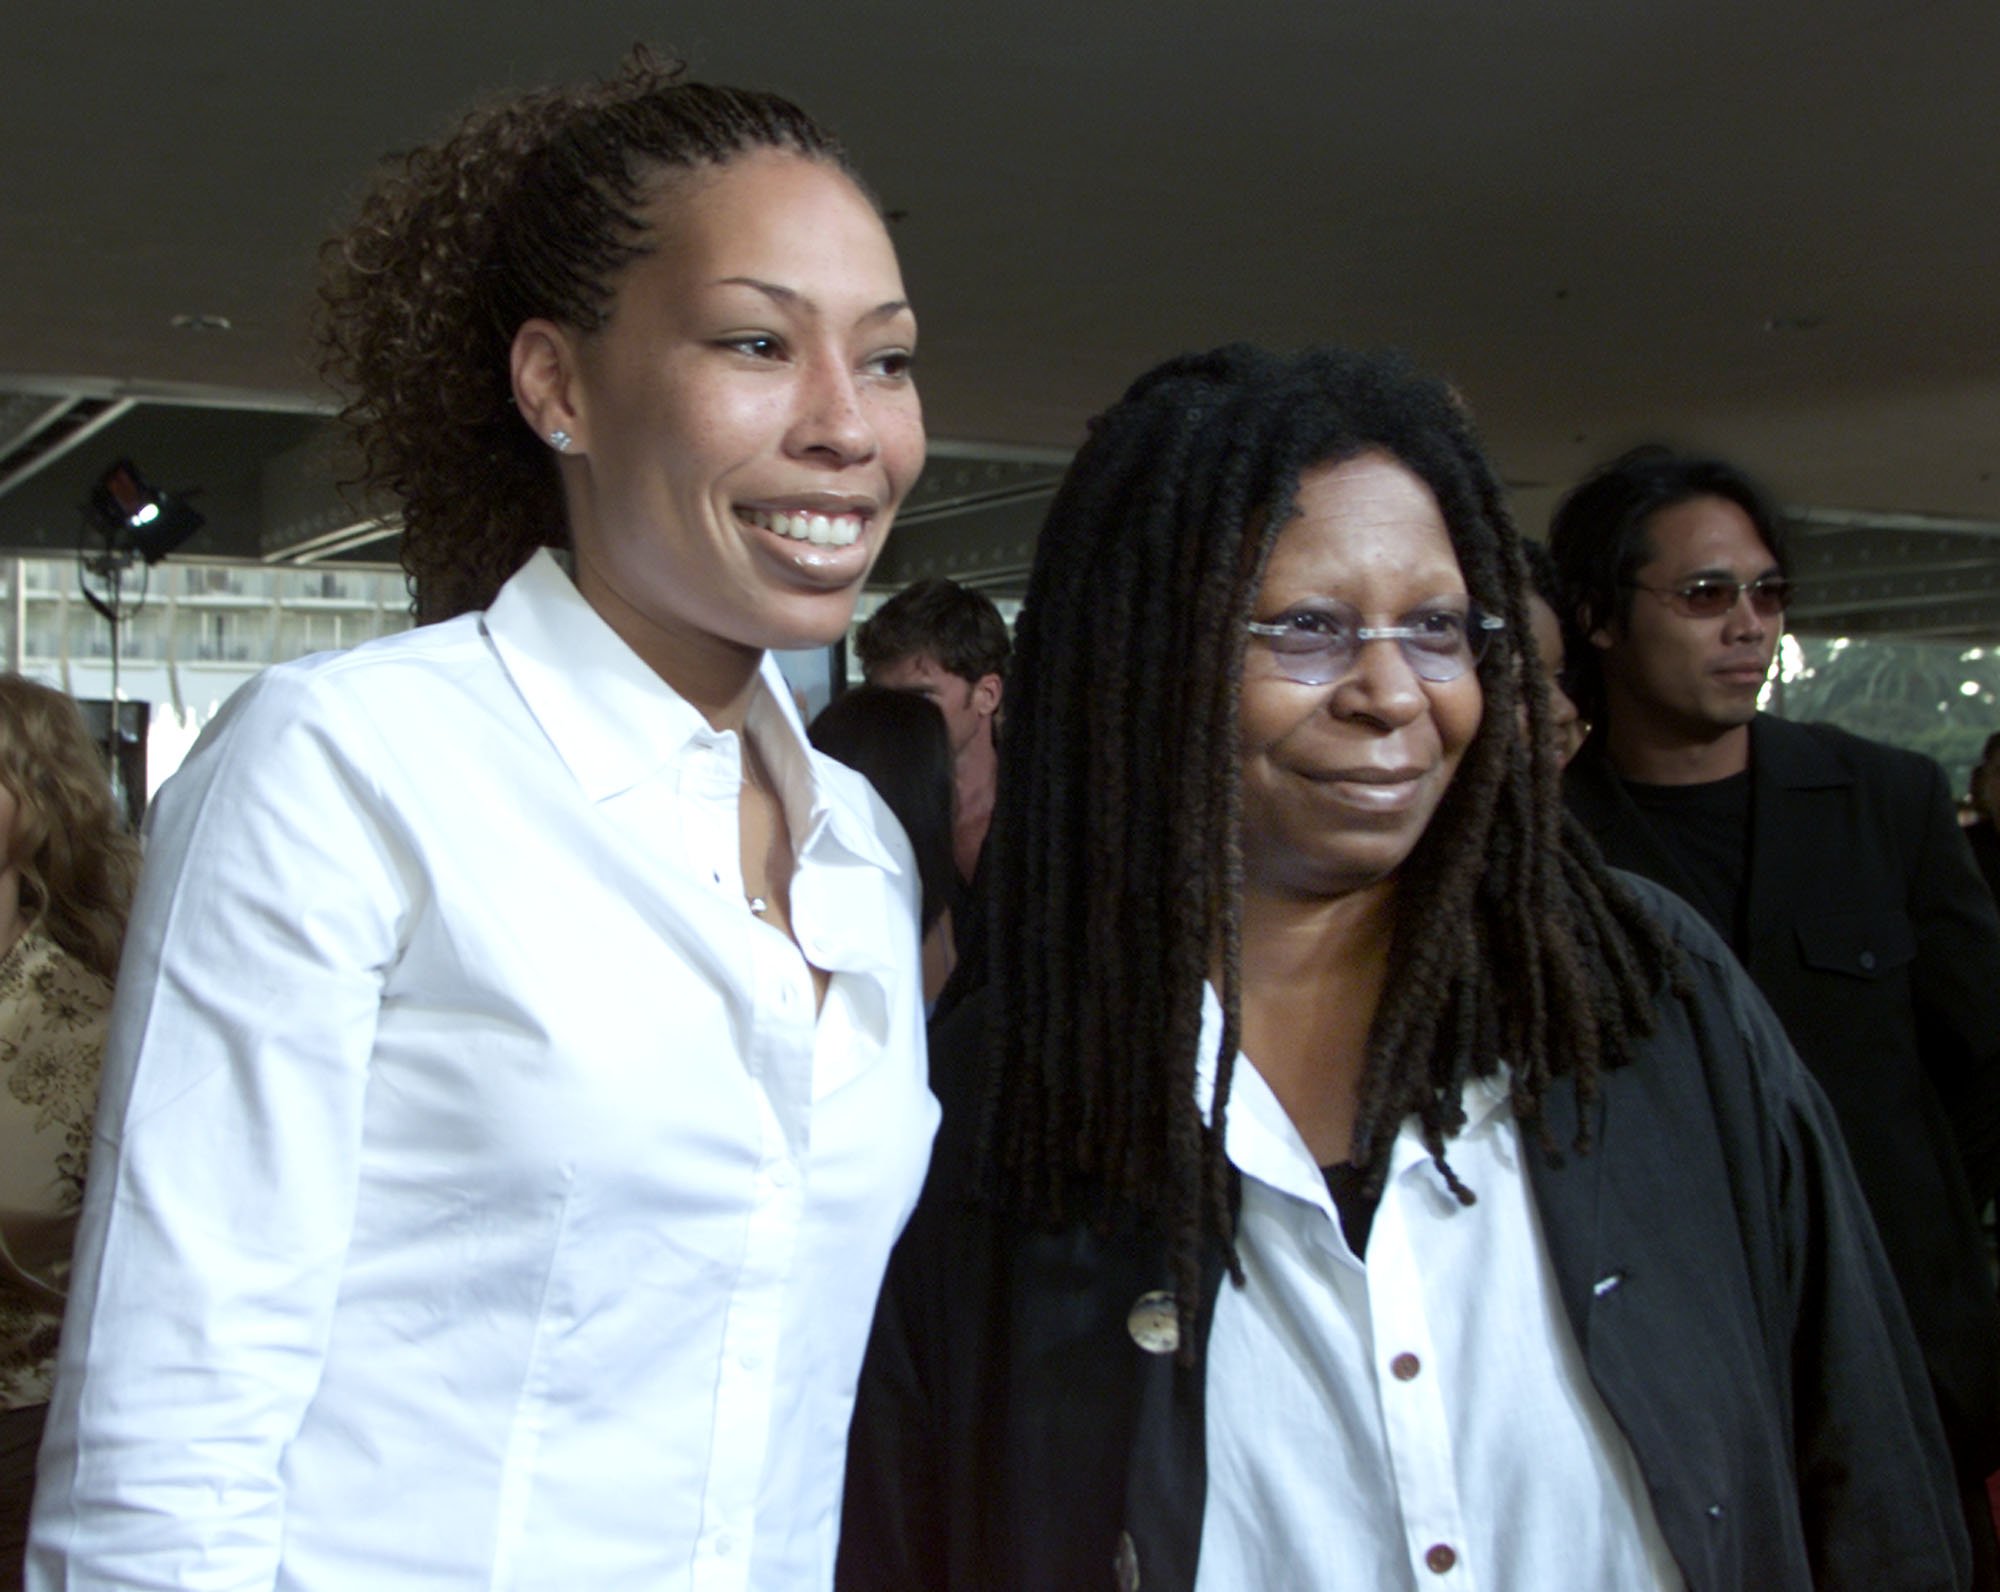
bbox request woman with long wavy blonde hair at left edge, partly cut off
[0,674,138,1588]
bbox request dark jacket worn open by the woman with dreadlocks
[836,886,1970,1592]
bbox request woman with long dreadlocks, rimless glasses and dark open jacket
[838,348,1966,1592]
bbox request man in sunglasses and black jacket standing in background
[1548,448,2000,1588]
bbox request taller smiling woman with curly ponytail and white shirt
[30,56,936,1592]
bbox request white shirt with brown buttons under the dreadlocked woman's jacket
[1196,992,1684,1592]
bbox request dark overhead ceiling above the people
[0,0,2000,640]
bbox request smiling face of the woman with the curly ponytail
[540,150,924,676]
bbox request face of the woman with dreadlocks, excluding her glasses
[1238,452,1484,896]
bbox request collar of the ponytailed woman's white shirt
[482,548,894,868]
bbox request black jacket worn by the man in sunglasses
[1566,714,2000,1476]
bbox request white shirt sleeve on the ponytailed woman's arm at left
[28,664,416,1592]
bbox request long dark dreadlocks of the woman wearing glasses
[982,346,1674,1344]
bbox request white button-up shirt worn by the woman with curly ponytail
[30,554,936,1592]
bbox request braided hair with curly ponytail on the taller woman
[318,48,868,622]
